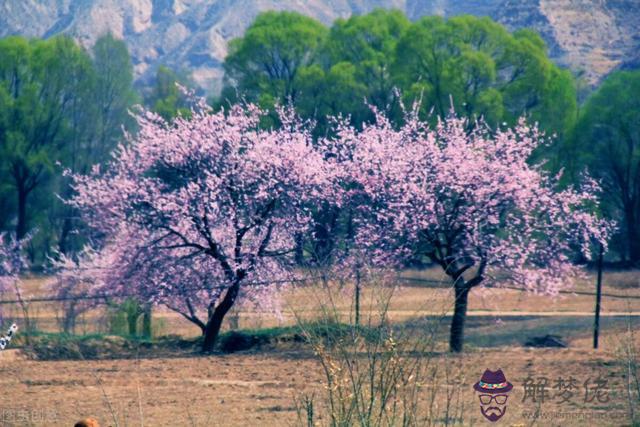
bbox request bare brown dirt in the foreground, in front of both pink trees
[0,341,629,426]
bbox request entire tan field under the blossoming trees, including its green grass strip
[0,271,640,426]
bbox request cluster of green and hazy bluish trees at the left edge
[0,35,135,254]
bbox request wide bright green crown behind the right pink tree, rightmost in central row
[395,16,576,134]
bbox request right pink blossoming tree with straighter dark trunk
[323,108,610,352]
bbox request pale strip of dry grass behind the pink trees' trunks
[3,269,640,336]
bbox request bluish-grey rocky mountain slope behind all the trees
[0,0,640,92]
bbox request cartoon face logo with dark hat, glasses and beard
[473,369,513,422]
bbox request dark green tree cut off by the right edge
[568,71,640,265]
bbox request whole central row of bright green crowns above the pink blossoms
[221,9,576,136]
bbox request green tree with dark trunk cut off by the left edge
[0,37,90,238]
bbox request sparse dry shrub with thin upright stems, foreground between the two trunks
[296,272,464,427]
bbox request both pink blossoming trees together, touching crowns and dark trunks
[72,98,609,352]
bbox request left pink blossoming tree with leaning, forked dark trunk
[71,104,329,352]
